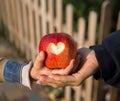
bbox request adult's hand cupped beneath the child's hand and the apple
[37,48,98,88]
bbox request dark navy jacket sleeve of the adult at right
[90,30,120,87]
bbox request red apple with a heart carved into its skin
[39,33,77,69]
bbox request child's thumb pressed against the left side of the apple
[34,51,45,69]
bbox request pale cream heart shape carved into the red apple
[48,42,65,55]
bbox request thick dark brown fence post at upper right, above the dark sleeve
[99,0,112,43]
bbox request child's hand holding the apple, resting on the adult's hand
[30,51,75,80]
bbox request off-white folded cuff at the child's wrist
[21,62,33,89]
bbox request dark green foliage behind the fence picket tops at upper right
[63,0,120,30]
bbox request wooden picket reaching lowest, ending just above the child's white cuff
[20,0,31,60]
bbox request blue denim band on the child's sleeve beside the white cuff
[4,61,23,83]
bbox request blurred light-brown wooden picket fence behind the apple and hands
[0,0,120,101]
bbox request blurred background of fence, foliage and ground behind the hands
[0,0,120,101]
